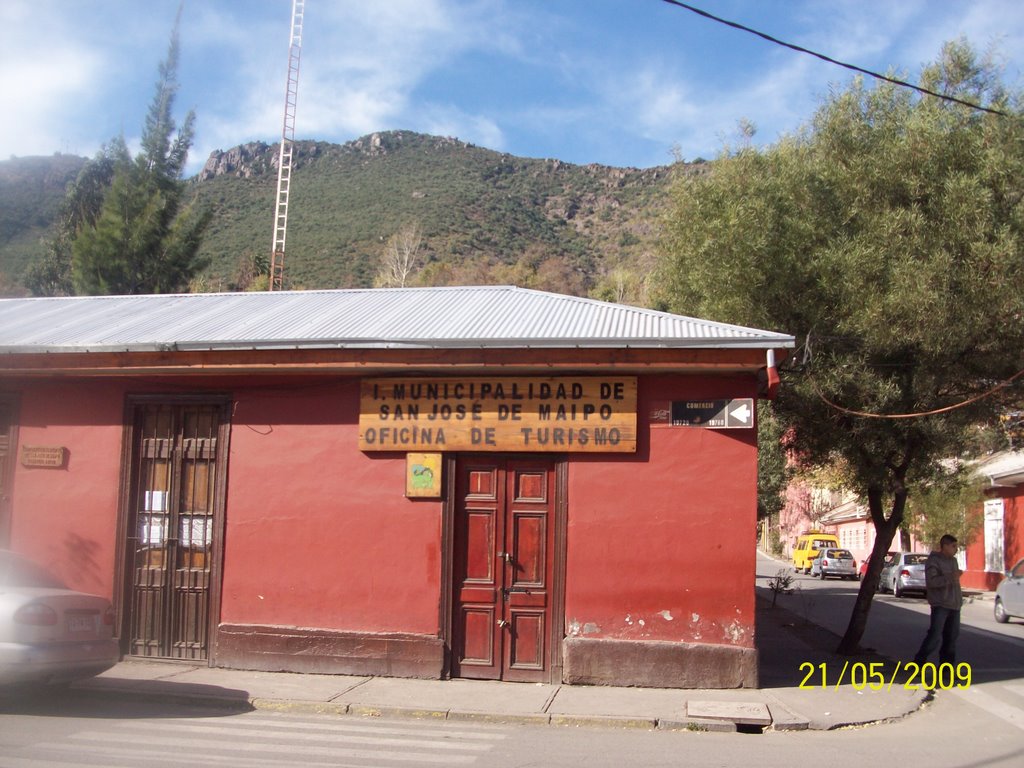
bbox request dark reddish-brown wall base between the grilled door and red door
[214,624,444,680]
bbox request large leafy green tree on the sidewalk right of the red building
[662,42,1024,652]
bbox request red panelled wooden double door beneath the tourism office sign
[452,456,561,682]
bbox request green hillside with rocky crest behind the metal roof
[0,131,700,294]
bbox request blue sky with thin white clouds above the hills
[0,0,1024,172]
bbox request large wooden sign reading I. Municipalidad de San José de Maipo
[359,376,637,453]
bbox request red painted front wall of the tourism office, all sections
[7,376,757,647]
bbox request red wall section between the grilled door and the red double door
[221,379,441,636]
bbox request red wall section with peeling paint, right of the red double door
[565,377,757,647]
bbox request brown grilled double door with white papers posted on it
[126,404,220,660]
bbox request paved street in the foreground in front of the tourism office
[0,690,1024,768]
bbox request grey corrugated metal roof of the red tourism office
[0,286,794,353]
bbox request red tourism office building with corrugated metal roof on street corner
[0,288,793,687]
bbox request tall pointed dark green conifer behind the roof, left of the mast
[71,18,211,294]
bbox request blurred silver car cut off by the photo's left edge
[0,550,121,685]
